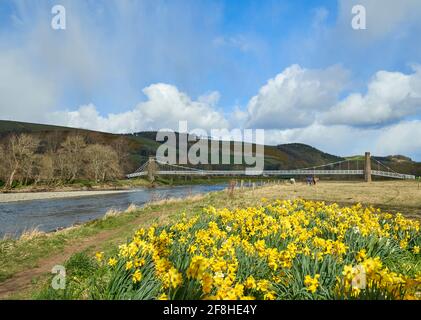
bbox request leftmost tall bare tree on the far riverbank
[5,134,39,188]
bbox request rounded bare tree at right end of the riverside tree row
[85,144,121,182]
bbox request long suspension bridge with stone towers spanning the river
[127,152,415,182]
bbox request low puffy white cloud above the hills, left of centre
[47,83,228,133]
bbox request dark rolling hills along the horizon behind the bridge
[0,120,421,175]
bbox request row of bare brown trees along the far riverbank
[0,133,127,189]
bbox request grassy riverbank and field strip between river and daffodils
[0,182,421,298]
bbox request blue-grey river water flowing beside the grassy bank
[0,185,226,239]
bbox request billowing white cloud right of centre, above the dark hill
[247,65,348,129]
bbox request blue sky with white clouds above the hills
[0,0,421,161]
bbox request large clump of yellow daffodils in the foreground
[97,200,421,300]
